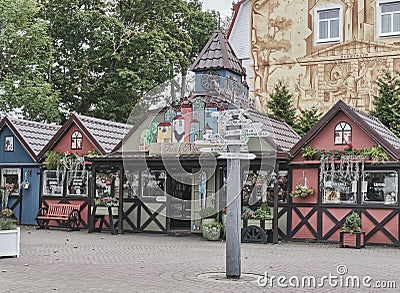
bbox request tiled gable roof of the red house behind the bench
[39,114,132,157]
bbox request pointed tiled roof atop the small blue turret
[190,30,246,76]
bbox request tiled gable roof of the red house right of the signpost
[291,100,400,160]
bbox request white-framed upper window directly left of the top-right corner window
[315,7,342,43]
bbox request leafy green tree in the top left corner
[0,0,59,122]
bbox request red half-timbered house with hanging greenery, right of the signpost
[288,101,400,246]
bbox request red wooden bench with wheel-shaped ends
[36,203,81,230]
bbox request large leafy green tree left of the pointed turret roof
[42,0,216,122]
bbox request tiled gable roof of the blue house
[0,117,61,161]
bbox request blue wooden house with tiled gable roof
[0,117,60,225]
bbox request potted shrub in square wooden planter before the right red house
[340,212,365,248]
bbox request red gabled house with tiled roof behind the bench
[36,114,131,227]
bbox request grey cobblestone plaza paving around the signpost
[0,227,400,292]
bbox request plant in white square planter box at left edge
[0,209,20,257]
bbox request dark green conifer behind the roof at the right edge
[370,70,400,137]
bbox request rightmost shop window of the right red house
[361,171,398,204]
